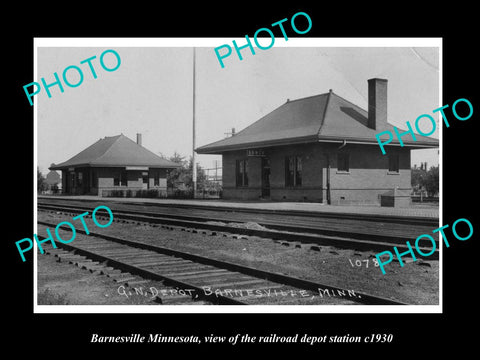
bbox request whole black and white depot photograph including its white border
[33,38,440,313]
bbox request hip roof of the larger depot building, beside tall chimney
[195,91,439,154]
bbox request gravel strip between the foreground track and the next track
[38,211,439,305]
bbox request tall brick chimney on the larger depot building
[367,78,388,130]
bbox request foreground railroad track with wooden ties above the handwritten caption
[38,221,406,305]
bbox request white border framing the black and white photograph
[33,37,443,314]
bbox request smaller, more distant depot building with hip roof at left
[49,134,179,197]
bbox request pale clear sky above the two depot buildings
[34,38,442,174]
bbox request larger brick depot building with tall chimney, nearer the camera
[196,78,439,206]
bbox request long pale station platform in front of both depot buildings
[38,195,439,219]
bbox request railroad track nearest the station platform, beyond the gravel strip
[38,202,439,259]
